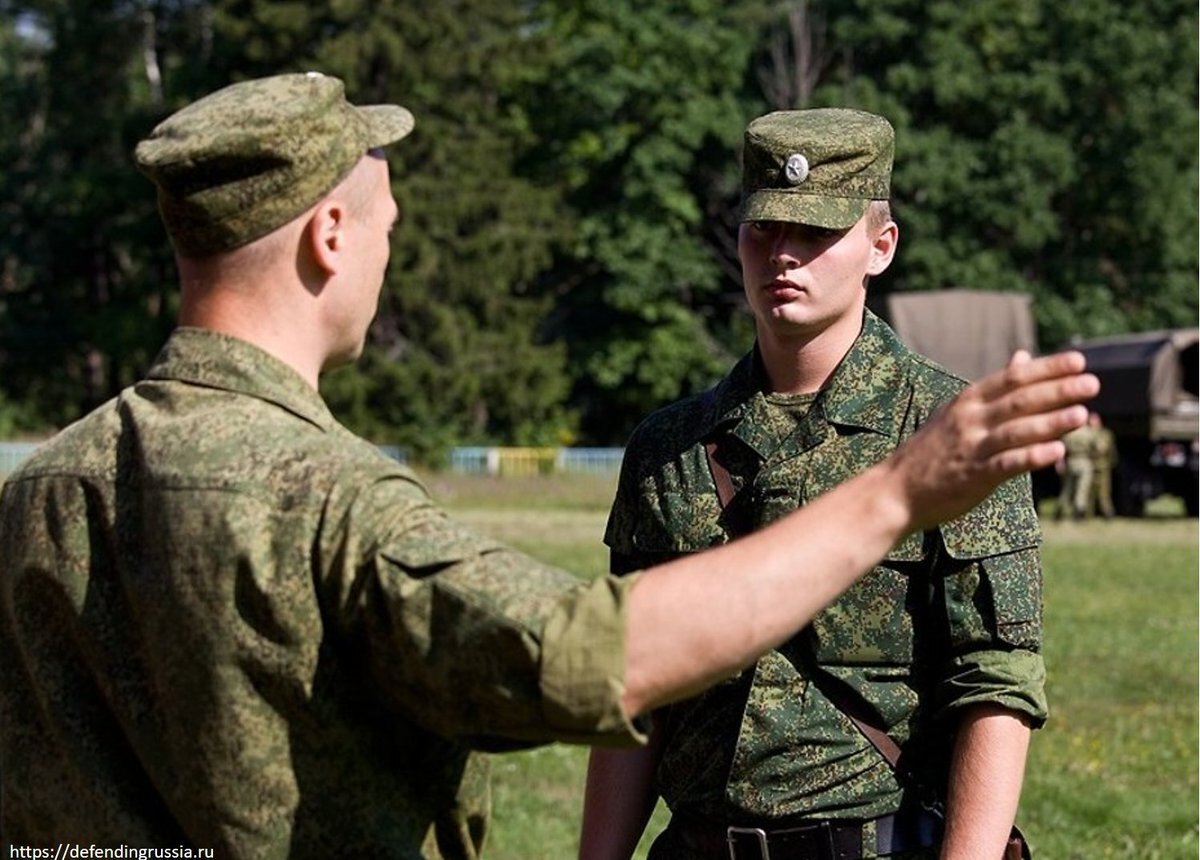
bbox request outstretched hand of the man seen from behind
[890,351,1100,530]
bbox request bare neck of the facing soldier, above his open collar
[756,314,863,395]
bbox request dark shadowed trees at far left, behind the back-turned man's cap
[0,0,188,425]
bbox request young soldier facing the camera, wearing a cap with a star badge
[581,109,1046,860]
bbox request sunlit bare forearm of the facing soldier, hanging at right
[941,705,1031,860]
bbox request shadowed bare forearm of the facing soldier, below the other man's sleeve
[580,729,662,860]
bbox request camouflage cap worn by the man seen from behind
[134,72,413,257]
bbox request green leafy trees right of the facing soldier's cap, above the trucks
[815,0,1196,347]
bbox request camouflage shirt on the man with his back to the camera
[0,329,636,859]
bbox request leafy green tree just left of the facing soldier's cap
[528,0,751,444]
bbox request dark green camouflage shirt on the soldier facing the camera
[605,313,1045,822]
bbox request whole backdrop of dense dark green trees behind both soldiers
[0,0,1200,458]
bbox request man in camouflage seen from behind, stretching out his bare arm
[0,73,1097,860]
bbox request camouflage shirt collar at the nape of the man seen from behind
[146,326,337,431]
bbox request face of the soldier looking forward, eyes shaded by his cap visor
[738,216,896,338]
